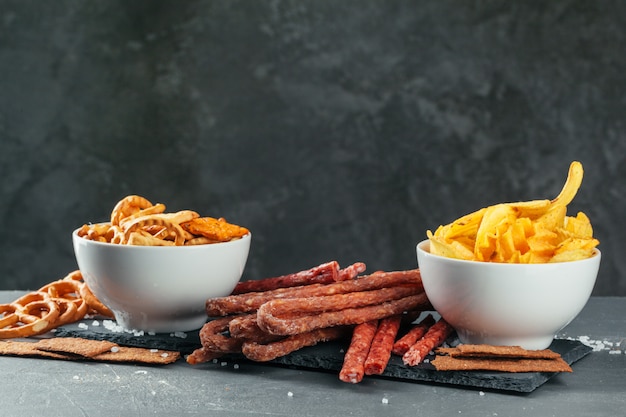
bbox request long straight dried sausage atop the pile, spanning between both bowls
[206,269,423,317]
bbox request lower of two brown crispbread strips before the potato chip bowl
[431,356,572,372]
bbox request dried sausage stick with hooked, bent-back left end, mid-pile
[257,292,430,335]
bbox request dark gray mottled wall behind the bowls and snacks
[0,0,626,295]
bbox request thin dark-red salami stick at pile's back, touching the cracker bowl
[232,261,339,294]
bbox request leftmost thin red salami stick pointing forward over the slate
[339,320,378,384]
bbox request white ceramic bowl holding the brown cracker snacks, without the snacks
[72,230,251,332]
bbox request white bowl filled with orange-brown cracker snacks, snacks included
[72,196,252,333]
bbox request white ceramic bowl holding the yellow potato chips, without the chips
[417,240,601,350]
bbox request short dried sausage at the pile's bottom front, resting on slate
[241,327,345,362]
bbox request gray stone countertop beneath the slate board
[0,291,626,417]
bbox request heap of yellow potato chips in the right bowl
[426,161,600,263]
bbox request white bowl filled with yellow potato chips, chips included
[416,161,601,350]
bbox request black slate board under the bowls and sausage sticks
[55,321,592,393]
